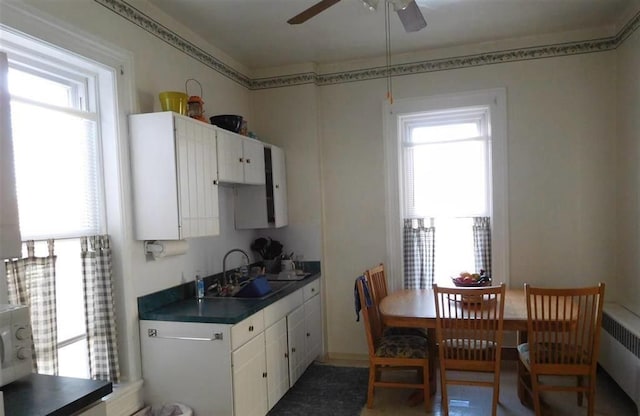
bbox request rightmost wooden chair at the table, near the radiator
[518,283,605,416]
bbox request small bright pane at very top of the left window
[9,68,73,108]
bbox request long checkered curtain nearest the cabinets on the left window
[80,235,120,383]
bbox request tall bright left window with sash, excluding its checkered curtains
[2,28,107,378]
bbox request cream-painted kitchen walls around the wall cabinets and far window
[1,0,640,370]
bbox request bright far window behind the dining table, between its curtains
[401,107,491,284]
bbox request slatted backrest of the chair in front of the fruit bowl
[433,283,506,371]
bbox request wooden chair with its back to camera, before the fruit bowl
[433,283,505,416]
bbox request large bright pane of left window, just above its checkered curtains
[11,101,102,240]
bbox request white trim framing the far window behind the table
[383,88,509,291]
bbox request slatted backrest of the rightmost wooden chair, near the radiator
[524,283,605,368]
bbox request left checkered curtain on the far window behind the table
[403,218,436,289]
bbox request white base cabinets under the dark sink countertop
[140,279,322,416]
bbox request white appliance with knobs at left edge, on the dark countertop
[0,305,33,386]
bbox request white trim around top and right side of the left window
[0,1,142,382]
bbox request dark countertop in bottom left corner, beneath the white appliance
[0,374,113,416]
